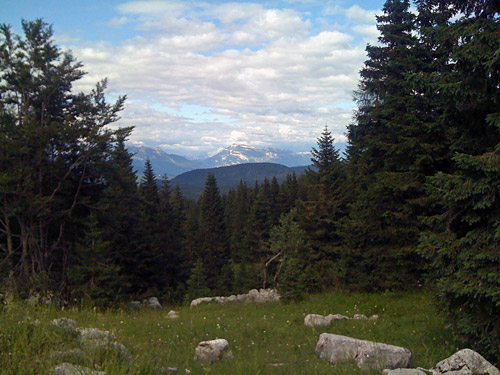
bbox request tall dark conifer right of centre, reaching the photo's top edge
[342,0,432,289]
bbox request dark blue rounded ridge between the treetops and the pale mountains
[171,163,308,199]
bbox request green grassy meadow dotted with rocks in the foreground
[0,291,457,375]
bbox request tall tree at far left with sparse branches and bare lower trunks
[0,20,125,296]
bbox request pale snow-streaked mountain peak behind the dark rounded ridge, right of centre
[202,145,311,168]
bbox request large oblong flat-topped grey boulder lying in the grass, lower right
[316,333,411,369]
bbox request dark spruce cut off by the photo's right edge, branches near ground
[419,1,500,362]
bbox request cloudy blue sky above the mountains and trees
[0,0,384,157]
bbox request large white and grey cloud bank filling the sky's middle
[67,1,373,152]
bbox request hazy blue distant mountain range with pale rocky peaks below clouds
[127,145,311,178]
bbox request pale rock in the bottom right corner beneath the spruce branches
[432,349,500,375]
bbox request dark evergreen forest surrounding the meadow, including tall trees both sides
[0,0,500,359]
